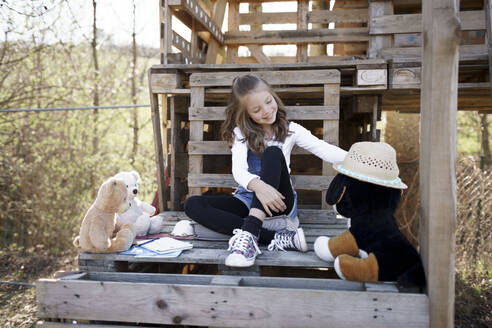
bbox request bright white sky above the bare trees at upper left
[0,0,159,48]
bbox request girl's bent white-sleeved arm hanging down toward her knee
[231,127,260,191]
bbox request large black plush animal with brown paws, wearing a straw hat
[314,142,425,287]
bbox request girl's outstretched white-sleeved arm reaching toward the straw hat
[289,122,347,163]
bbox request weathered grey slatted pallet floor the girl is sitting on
[79,209,348,275]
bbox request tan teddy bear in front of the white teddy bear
[73,178,135,253]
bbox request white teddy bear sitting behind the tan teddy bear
[114,171,162,236]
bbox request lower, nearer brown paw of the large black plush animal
[334,253,379,282]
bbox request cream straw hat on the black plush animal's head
[333,141,407,189]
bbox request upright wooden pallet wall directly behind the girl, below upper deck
[149,60,387,210]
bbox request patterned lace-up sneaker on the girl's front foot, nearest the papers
[225,229,261,267]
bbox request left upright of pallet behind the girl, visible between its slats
[188,87,205,196]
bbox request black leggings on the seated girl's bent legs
[185,147,294,244]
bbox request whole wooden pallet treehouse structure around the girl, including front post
[37,0,482,327]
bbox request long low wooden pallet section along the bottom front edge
[36,272,429,328]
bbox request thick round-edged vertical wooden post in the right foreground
[420,0,461,327]
